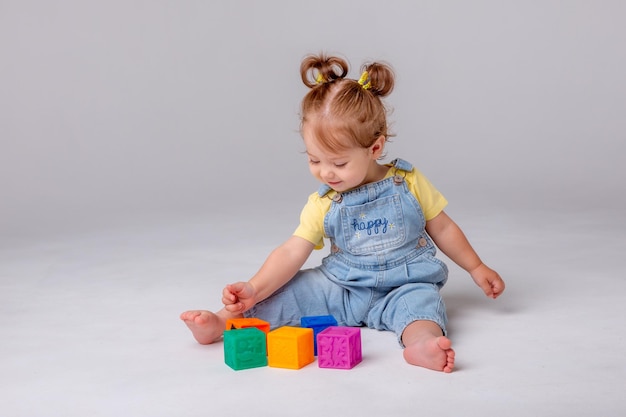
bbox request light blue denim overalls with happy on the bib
[245,159,448,343]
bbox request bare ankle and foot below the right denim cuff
[402,320,454,372]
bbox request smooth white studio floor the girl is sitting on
[0,206,626,417]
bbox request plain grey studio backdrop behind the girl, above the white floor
[0,0,626,237]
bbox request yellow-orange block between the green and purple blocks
[267,326,315,369]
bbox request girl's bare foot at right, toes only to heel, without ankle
[404,336,454,372]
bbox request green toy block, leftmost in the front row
[224,327,267,371]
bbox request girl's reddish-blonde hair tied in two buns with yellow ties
[300,53,395,152]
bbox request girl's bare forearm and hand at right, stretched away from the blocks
[426,211,504,298]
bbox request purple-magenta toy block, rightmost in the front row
[317,326,363,369]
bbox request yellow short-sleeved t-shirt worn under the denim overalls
[293,168,448,249]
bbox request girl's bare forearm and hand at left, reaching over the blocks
[222,236,315,313]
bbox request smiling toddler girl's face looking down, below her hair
[302,122,380,192]
